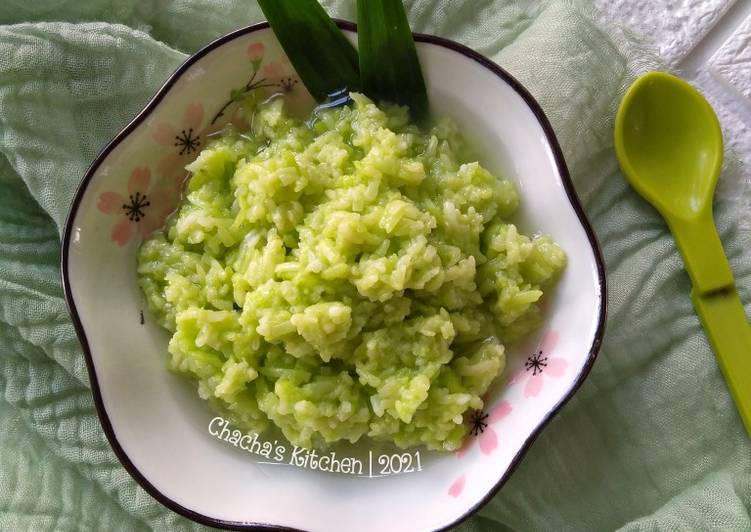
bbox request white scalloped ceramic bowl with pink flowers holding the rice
[62,22,605,532]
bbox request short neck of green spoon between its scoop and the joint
[666,208,735,295]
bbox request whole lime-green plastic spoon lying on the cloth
[615,72,751,435]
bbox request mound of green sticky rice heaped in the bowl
[138,94,566,451]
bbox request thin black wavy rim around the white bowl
[61,20,607,530]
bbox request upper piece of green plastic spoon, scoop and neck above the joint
[615,72,735,294]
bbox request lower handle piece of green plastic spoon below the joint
[691,288,751,435]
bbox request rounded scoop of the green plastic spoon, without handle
[616,72,723,219]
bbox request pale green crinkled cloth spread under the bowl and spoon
[0,0,751,531]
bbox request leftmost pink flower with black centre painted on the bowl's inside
[97,167,179,247]
